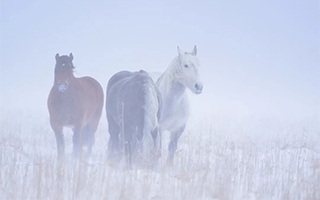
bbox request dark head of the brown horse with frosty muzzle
[54,53,74,92]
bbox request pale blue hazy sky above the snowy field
[0,0,320,120]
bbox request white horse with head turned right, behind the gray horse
[156,46,203,164]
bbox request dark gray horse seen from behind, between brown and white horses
[106,70,161,168]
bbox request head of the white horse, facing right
[175,46,203,94]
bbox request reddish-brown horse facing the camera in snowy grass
[48,53,104,158]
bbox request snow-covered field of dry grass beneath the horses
[0,111,320,200]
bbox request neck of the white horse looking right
[157,57,186,99]
